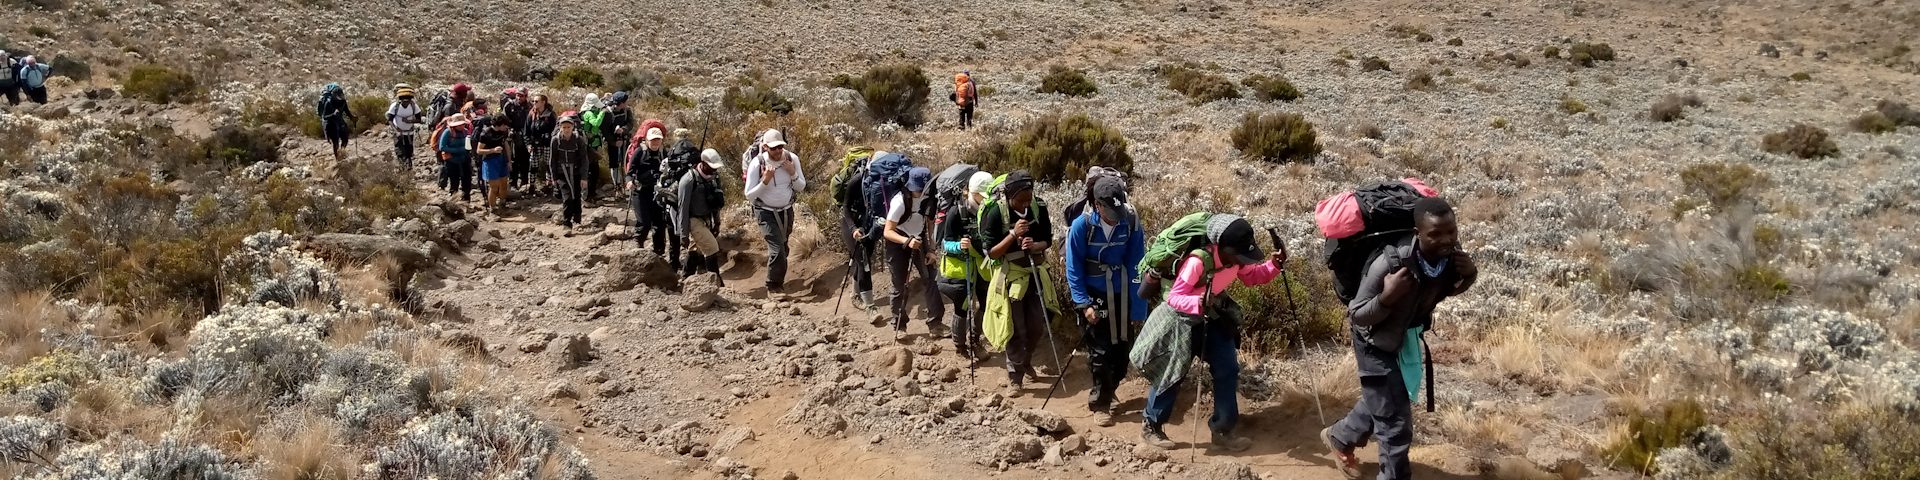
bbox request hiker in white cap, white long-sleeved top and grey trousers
[747,131,806,291]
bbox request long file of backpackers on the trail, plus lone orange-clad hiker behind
[349,73,1478,478]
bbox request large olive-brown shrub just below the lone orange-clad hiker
[968,113,1133,182]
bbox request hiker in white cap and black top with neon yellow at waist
[933,171,993,359]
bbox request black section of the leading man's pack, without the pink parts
[1325,180,1423,303]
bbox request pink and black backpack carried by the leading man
[1313,179,1440,303]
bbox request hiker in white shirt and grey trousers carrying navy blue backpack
[881,167,947,342]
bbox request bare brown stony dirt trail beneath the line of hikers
[301,138,1478,480]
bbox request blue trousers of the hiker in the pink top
[1121,321,1240,434]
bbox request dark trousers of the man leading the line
[1329,334,1413,480]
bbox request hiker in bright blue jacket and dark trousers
[1066,177,1148,426]
